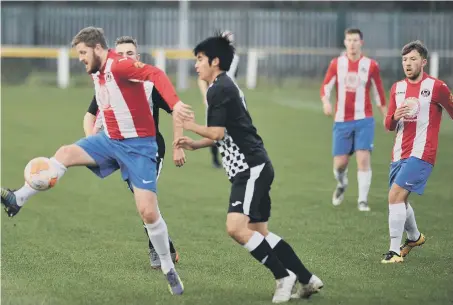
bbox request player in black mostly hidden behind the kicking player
[83,36,185,269]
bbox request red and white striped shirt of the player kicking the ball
[92,50,179,139]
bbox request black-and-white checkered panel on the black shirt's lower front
[216,133,249,179]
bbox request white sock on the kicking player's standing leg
[145,216,175,274]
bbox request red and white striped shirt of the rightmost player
[385,73,453,165]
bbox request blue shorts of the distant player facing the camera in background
[332,118,374,156]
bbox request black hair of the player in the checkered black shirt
[193,31,236,71]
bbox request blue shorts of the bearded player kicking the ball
[75,132,157,193]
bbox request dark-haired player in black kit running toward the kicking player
[174,33,323,303]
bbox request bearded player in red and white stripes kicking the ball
[1,27,192,294]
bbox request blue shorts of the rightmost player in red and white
[389,157,433,195]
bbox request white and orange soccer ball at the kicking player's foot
[24,157,58,191]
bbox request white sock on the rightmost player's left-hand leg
[389,202,406,254]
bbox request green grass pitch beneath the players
[1,86,453,305]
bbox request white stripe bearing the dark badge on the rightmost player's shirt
[411,78,435,159]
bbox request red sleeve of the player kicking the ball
[112,58,180,110]
